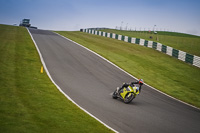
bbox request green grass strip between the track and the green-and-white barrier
[57,31,200,107]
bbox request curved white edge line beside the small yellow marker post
[27,28,118,133]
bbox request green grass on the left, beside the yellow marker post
[0,25,111,133]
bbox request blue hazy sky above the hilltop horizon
[0,0,200,36]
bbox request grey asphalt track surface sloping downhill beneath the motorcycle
[29,29,200,133]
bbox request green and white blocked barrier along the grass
[81,29,200,68]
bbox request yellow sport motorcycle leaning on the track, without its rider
[112,85,139,104]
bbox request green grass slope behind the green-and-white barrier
[102,29,200,56]
